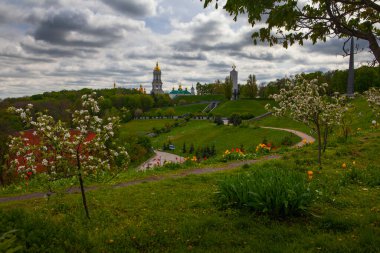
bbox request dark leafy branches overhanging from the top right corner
[201,0,380,63]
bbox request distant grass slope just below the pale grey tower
[212,99,273,116]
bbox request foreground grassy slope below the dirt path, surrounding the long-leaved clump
[0,129,380,252]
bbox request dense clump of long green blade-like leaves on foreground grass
[217,166,313,217]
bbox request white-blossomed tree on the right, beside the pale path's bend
[266,78,344,168]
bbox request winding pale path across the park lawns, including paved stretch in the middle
[0,127,315,203]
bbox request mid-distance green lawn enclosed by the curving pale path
[152,120,300,155]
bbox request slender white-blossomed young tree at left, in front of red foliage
[9,92,128,217]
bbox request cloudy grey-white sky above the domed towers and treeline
[0,0,371,98]
